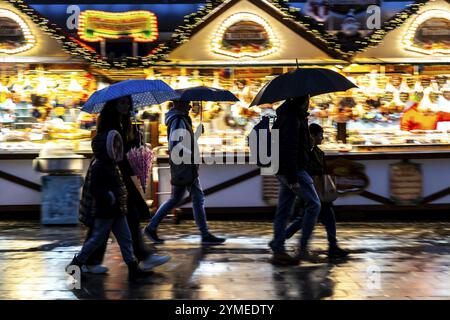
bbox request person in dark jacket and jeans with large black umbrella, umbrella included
[250,68,356,265]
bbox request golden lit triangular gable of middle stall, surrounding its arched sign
[156,0,345,66]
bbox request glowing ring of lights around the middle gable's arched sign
[212,12,280,58]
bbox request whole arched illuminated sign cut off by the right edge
[403,10,450,54]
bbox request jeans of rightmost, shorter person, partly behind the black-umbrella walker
[286,203,337,248]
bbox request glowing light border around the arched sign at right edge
[402,9,450,54]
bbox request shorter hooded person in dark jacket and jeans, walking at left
[69,130,147,280]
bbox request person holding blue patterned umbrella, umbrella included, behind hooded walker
[80,80,178,274]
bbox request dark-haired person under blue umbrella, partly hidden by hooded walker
[80,96,170,273]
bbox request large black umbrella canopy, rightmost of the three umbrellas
[250,68,357,107]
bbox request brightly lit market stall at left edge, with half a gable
[0,1,97,212]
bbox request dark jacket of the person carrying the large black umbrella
[272,100,311,183]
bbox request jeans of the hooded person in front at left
[77,215,135,264]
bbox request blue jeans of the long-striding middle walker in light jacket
[147,178,209,236]
